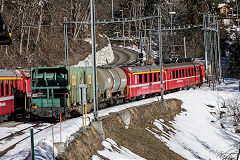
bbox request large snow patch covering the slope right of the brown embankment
[147,80,240,159]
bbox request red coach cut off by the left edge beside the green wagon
[0,69,31,120]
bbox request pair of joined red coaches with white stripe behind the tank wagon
[122,62,204,99]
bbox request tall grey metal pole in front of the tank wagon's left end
[90,0,98,120]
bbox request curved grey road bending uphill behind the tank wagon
[110,46,138,67]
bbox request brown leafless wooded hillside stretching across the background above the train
[0,0,234,68]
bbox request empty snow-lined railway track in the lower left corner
[0,122,52,157]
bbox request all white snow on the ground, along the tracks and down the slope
[0,79,240,160]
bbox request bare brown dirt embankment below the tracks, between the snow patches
[62,99,184,160]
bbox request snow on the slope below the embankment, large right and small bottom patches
[93,79,240,160]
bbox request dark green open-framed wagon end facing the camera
[30,66,69,117]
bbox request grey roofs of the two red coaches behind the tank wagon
[126,62,200,72]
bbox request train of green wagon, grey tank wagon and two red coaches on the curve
[29,62,204,118]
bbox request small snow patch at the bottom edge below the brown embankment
[92,138,145,160]
